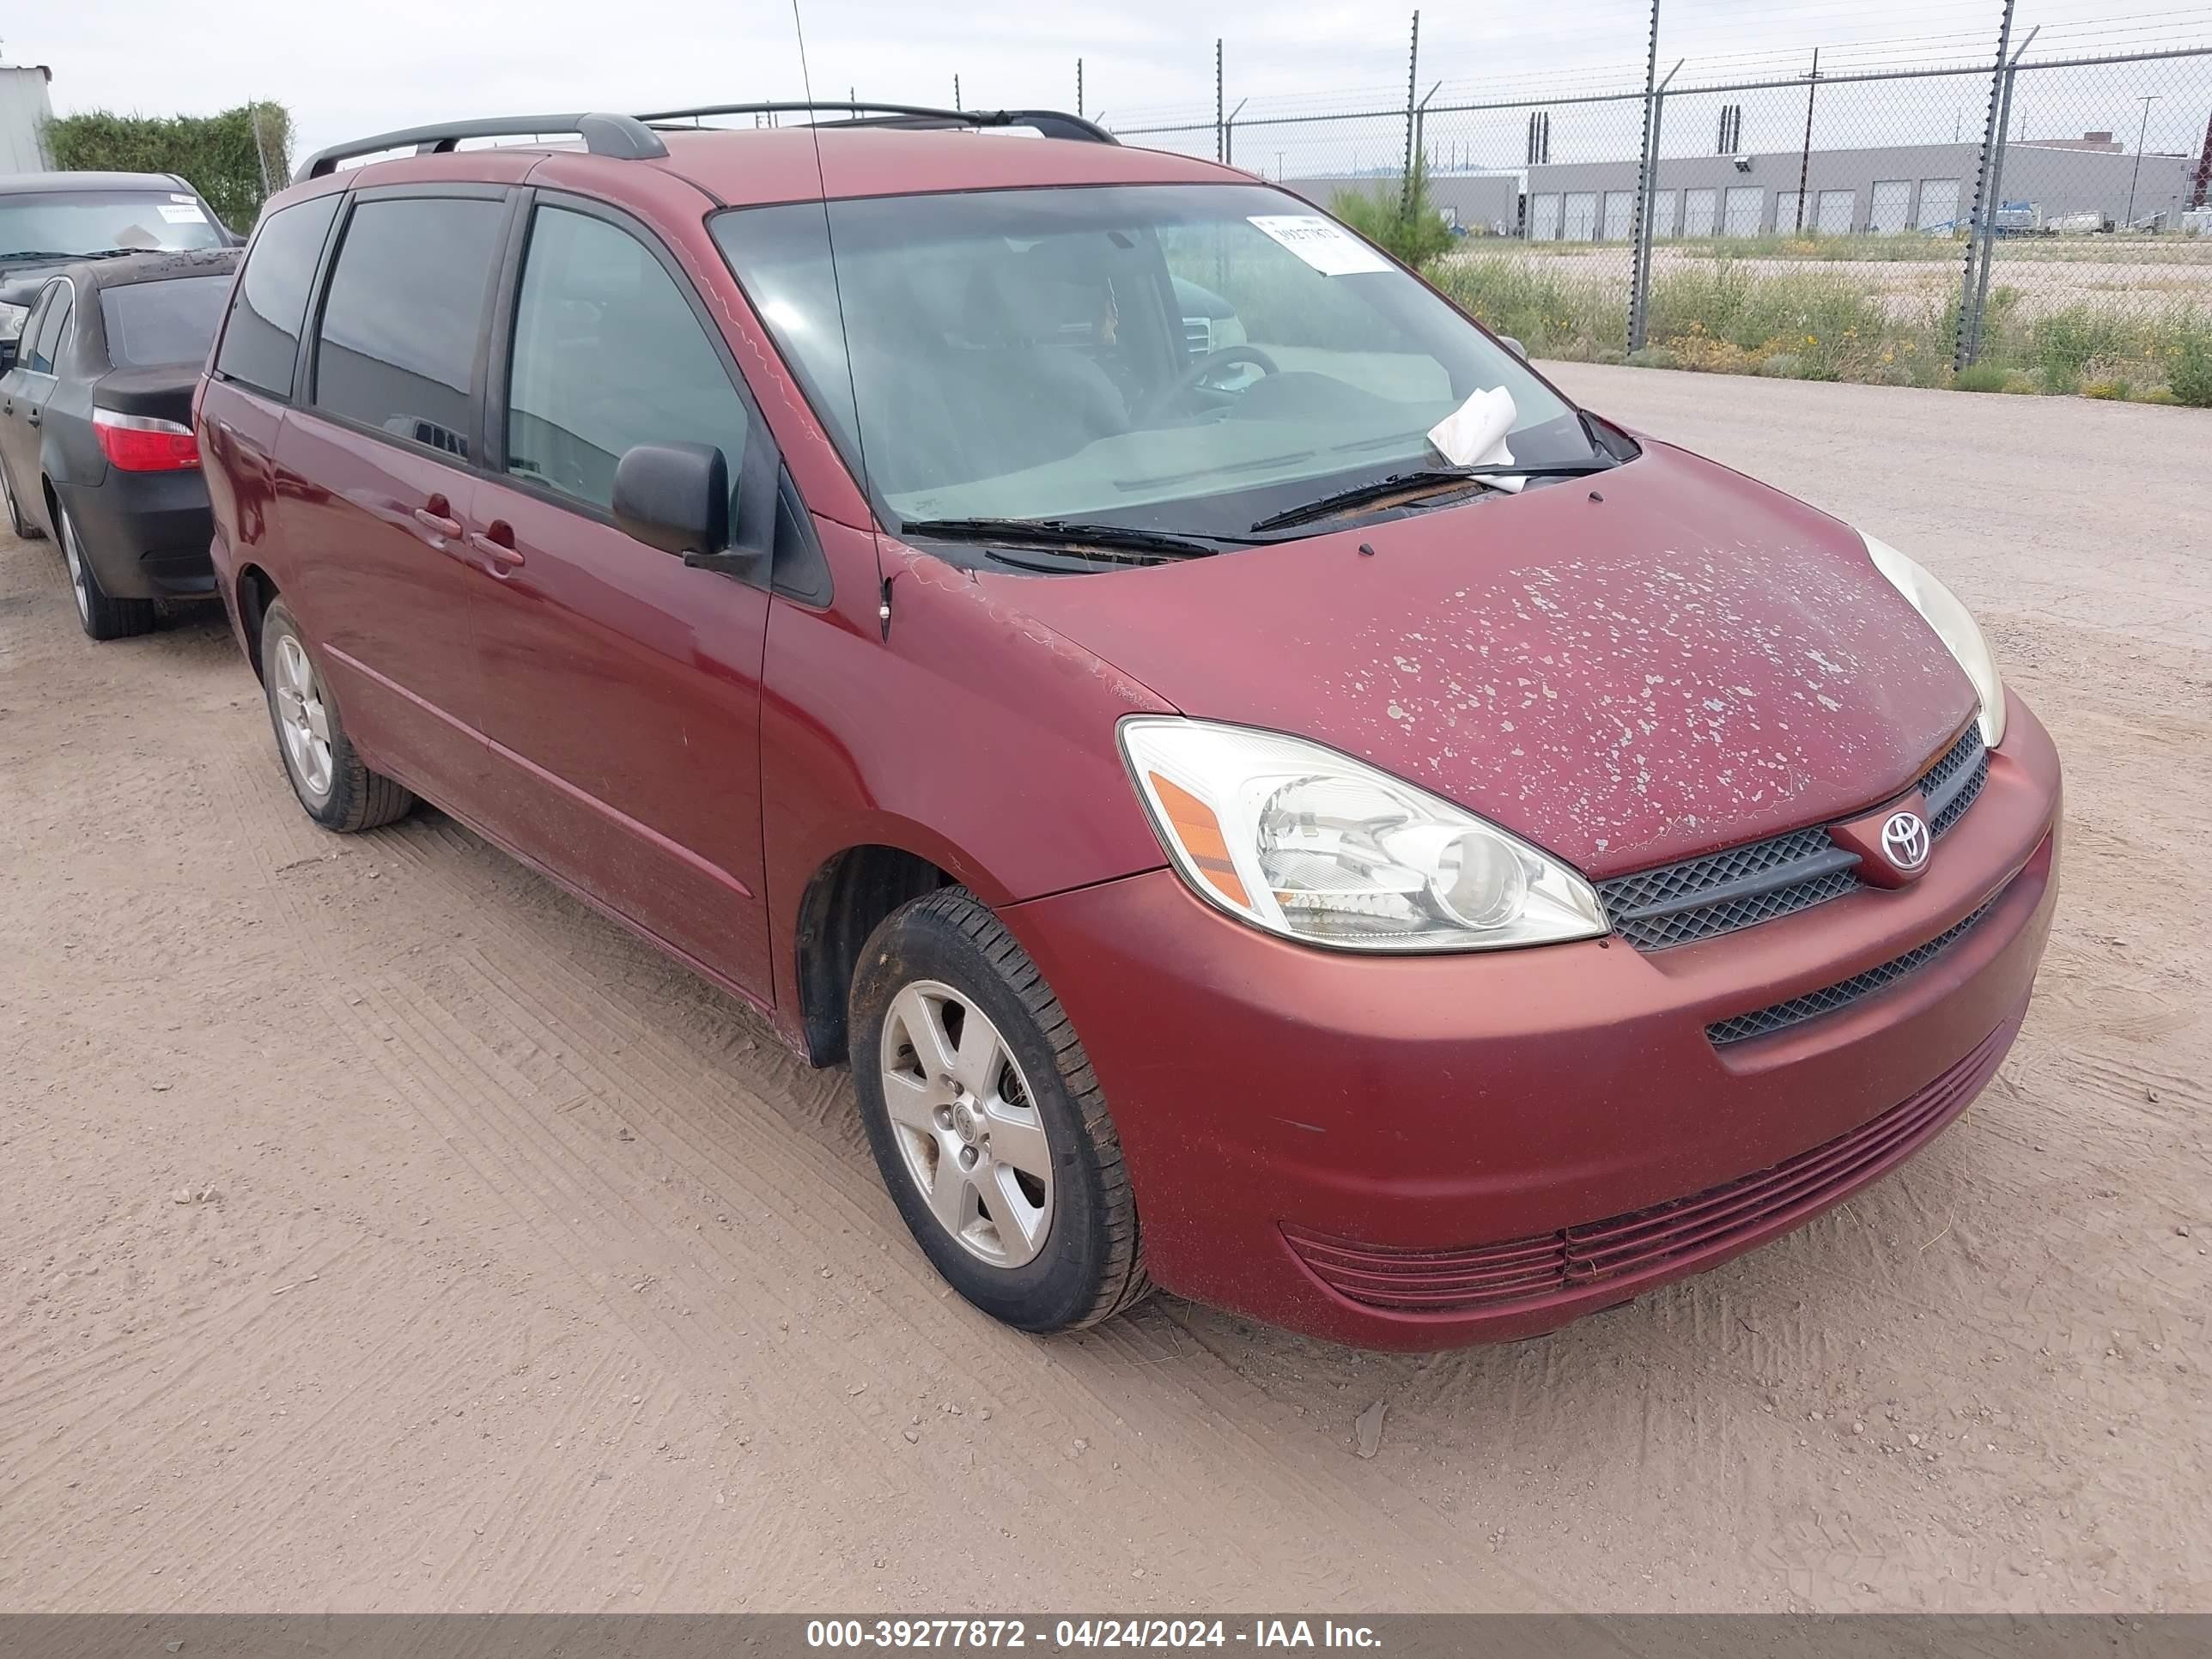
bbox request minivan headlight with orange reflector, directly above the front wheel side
[1121,717,1608,951]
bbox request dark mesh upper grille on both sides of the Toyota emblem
[1597,726,1989,951]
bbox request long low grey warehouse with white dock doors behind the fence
[1526,133,2197,241]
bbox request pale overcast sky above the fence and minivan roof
[17,0,2212,173]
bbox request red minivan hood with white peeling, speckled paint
[995,441,1975,878]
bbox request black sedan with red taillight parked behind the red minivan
[0,248,239,639]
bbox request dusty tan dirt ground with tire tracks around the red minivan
[0,368,2212,1613]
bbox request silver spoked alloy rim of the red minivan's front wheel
[883,980,1053,1267]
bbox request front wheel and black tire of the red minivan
[848,887,1151,1332]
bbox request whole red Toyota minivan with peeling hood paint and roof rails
[197,106,2059,1349]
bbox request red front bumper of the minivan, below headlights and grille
[1006,699,2059,1349]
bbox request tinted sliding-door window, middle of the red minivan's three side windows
[314,197,507,456]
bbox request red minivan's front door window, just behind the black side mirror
[507,208,748,507]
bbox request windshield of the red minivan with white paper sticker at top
[714,184,1593,538]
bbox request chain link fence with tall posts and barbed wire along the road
[1110,35,2212,404]
